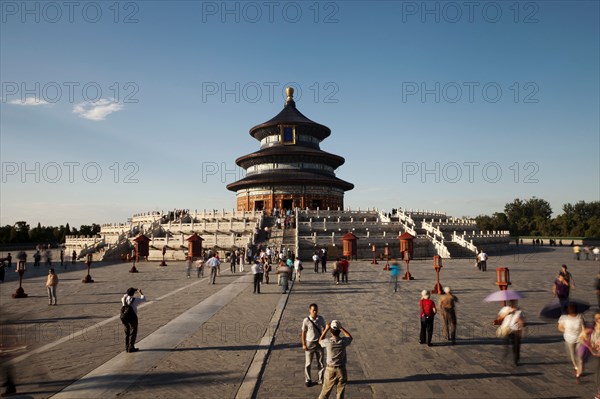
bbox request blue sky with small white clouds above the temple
[0,1,600,225]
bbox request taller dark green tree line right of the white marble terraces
[475,197,600,237]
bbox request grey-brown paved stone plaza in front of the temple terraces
[0,246,599,398]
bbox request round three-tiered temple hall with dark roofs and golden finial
[227,87,354,214]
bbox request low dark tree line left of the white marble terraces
[0,221,100,244]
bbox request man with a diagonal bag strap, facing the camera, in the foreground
[301,303,326,387]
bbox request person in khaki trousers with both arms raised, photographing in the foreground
[319,320,352,399]
